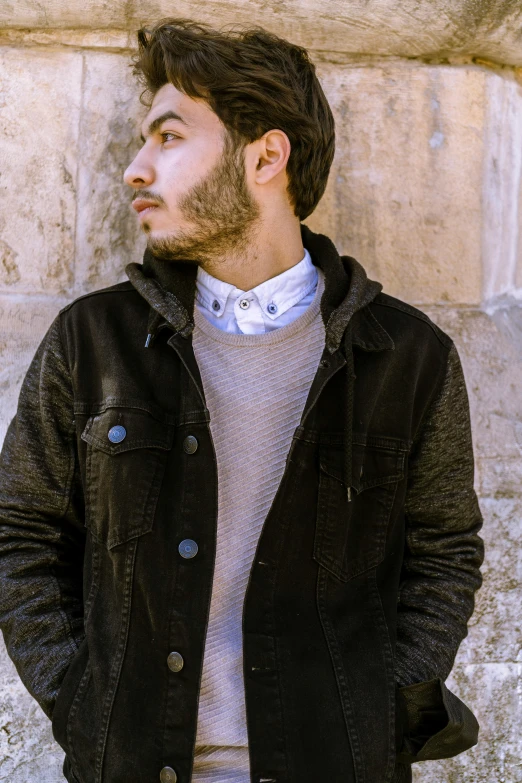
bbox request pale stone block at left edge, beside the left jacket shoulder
[0,294,71,444]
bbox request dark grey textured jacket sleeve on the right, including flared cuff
[396,345,484,760]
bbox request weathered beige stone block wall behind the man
[0,0,522,783]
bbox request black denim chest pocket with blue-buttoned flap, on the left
[81,408,174,549]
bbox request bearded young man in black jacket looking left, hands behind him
[0,13,483,783]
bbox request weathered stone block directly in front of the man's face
[76,53,147,292]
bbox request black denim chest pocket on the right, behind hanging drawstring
[313,437,407,582]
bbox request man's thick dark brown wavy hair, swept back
[131,18,335,220]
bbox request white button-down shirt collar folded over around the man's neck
[196,248,317,320]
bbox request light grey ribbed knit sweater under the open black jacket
[192,270,325,783]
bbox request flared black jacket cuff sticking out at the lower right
[397,678,479,764]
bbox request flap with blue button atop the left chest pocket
[81,408,174,455]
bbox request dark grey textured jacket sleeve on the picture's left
[0,315,85,718]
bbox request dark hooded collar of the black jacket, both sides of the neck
[125,223,394,354]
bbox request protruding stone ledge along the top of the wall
[0,0,522,65]
